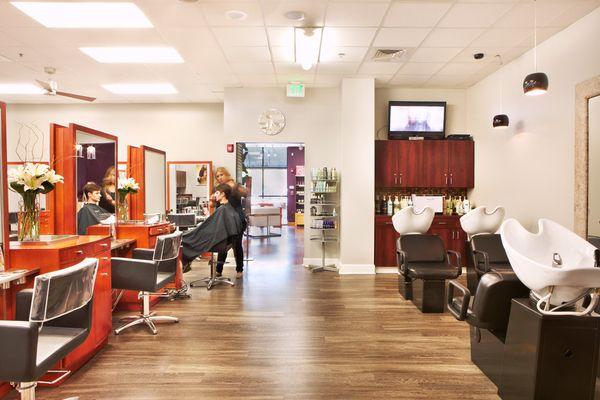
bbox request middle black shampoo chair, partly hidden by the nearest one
[467,233,512,294]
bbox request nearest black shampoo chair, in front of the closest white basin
[447,269,529,385]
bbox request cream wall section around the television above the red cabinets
[375,87,467,140]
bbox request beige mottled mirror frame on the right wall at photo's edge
[573,75,600,239]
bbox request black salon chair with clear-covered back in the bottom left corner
[0,258,98,399]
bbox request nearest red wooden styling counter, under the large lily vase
[8,236,112,385]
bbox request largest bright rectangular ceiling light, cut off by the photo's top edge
[11,1,152,28]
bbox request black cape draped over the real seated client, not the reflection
[181,203,244,262]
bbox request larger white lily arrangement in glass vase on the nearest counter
[8,163,64,241]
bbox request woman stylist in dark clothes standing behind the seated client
[215,167,248,279]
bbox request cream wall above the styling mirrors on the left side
[7,104,226,165]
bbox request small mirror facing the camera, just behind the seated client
[167,161,213,216]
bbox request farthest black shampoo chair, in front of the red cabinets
[396,234,462,313]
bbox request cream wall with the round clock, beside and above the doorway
[223,88,344,263]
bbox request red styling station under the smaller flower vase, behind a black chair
[87,222,183,311]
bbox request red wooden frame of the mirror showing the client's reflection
[46,124,119,235]
